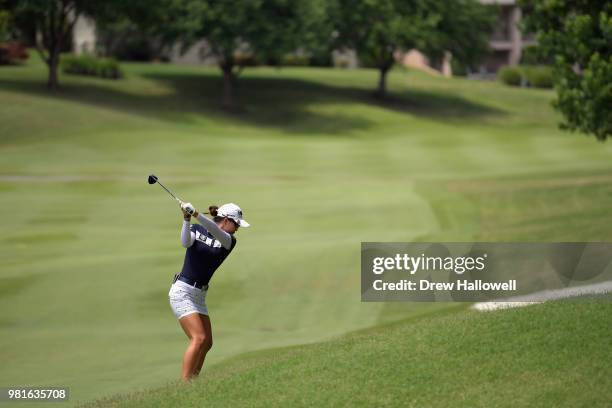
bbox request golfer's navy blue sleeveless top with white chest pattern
[181,224,236,285]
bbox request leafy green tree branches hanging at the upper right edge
[520,0,612,141]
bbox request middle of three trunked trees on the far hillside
[159,0,325,108]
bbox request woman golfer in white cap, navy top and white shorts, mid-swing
[168,203,249,383]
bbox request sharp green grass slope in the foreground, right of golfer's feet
[91,301,612,408]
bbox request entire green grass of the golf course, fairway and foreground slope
[0,53,612,407]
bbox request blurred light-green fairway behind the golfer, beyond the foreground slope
[0,55,612,402]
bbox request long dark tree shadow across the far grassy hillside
[0,69,504,135]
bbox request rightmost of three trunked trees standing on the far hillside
[337,0,494,96]
